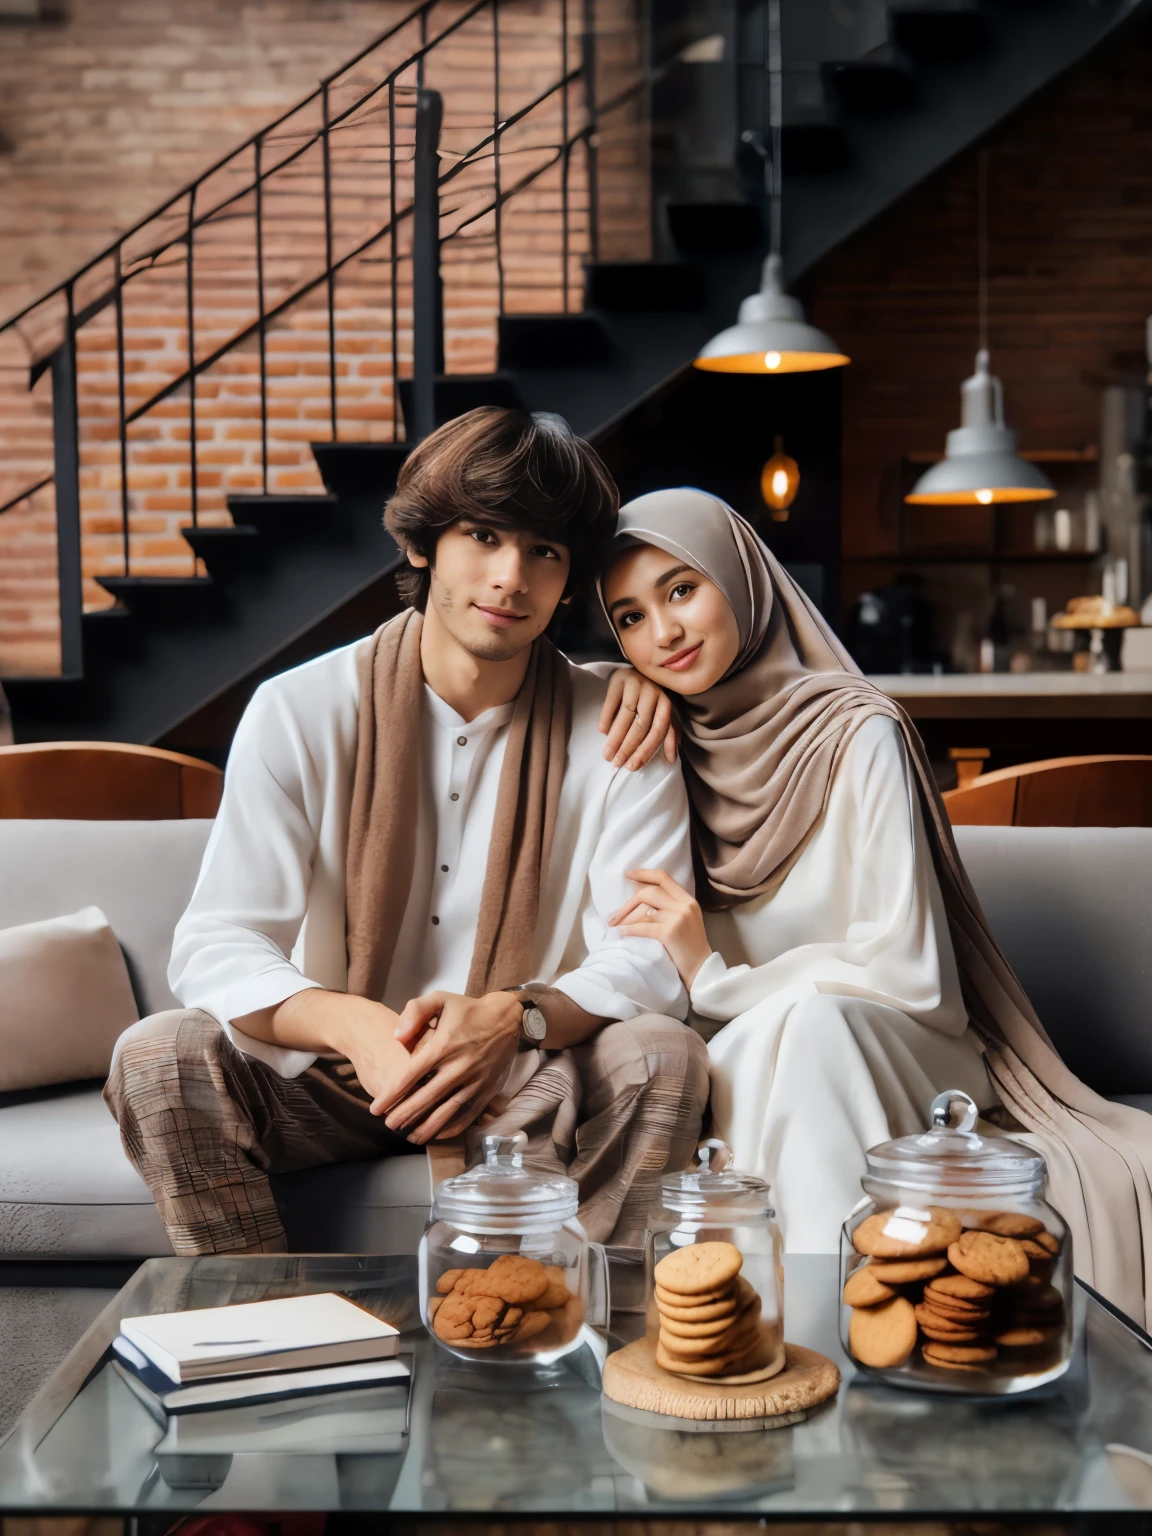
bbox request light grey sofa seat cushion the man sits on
[0,1086,432,1260]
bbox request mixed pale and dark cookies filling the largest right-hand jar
[843,1206,1066,1372]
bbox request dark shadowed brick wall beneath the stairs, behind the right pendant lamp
[811,26,1152,591]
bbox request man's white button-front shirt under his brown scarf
[169,639,691,1077]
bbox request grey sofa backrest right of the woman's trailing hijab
[955,826,1152,1107]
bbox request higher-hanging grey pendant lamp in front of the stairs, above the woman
[696,0,849,373]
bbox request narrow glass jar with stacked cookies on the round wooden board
[645,1140,783,1384]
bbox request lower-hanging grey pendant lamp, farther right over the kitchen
[905,149,1055,507]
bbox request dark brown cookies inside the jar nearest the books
[429,1253,584,1350]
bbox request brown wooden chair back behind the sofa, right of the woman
[943,756,1152,826]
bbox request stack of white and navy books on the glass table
[112,1292,410,1455]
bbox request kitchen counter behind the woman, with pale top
[869,671,1152,720]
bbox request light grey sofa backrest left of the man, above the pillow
[0,819,212,1018]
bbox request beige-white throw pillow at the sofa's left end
[0,906,140,1092]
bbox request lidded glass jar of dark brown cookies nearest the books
[419,1132,608,1366]
